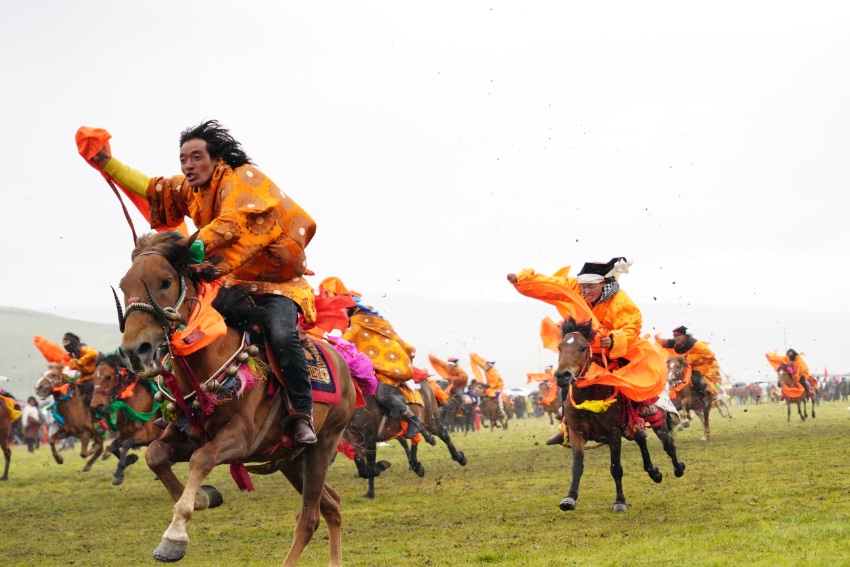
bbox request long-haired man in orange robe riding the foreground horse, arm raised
[88,120,316,445]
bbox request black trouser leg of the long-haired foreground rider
[254,294,313,415]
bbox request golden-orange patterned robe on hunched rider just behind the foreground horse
[342,308,416,387]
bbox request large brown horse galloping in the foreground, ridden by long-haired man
[116,233,355,567]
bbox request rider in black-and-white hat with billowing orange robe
[508,257,667,445]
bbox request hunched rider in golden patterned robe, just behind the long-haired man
[321,278,433,443]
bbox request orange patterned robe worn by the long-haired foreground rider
[147,163,316,324]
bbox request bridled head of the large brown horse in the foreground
[113,232,207,377]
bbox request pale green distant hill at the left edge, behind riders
[0,307,121,398]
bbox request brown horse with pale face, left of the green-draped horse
[35,363,103,472]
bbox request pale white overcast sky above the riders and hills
[0,1,850,382]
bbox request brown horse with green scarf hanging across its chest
[91,355,162,486]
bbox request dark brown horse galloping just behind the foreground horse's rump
[345,380,467,498]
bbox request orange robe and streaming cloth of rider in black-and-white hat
[514,266,667,402]
